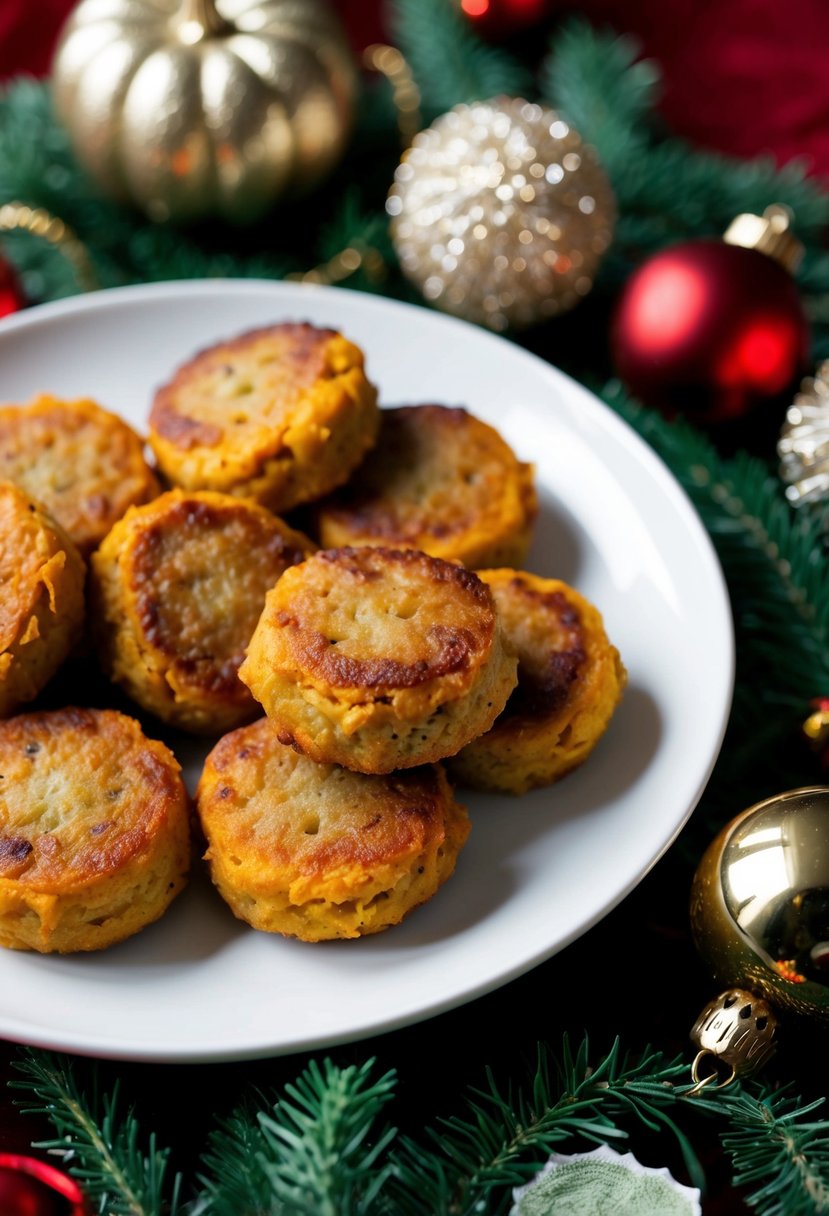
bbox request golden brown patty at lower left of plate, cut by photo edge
[0,709,190,953]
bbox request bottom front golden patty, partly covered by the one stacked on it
[197,719,469,941]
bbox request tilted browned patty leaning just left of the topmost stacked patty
[91,490,314,734]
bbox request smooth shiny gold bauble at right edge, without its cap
[690,787,829,1024]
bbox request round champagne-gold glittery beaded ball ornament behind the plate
[385,97,615,331]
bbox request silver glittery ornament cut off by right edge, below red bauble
[777,360,829,507]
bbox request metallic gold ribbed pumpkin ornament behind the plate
[53,0,357,223]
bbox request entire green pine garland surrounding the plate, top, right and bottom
[0,0,829,1216]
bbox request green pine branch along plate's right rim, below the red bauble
[602,382,829,814]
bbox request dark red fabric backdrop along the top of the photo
[0,0,829,178]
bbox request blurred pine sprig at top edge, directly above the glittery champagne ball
[388,0,532,118]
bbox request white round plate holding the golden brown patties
[0,281,733,1060]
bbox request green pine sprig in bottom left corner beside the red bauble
[10,1052,181,1216]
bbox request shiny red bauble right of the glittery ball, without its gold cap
[610,240,810,423]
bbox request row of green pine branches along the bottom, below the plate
[11,1037,829,1216]
